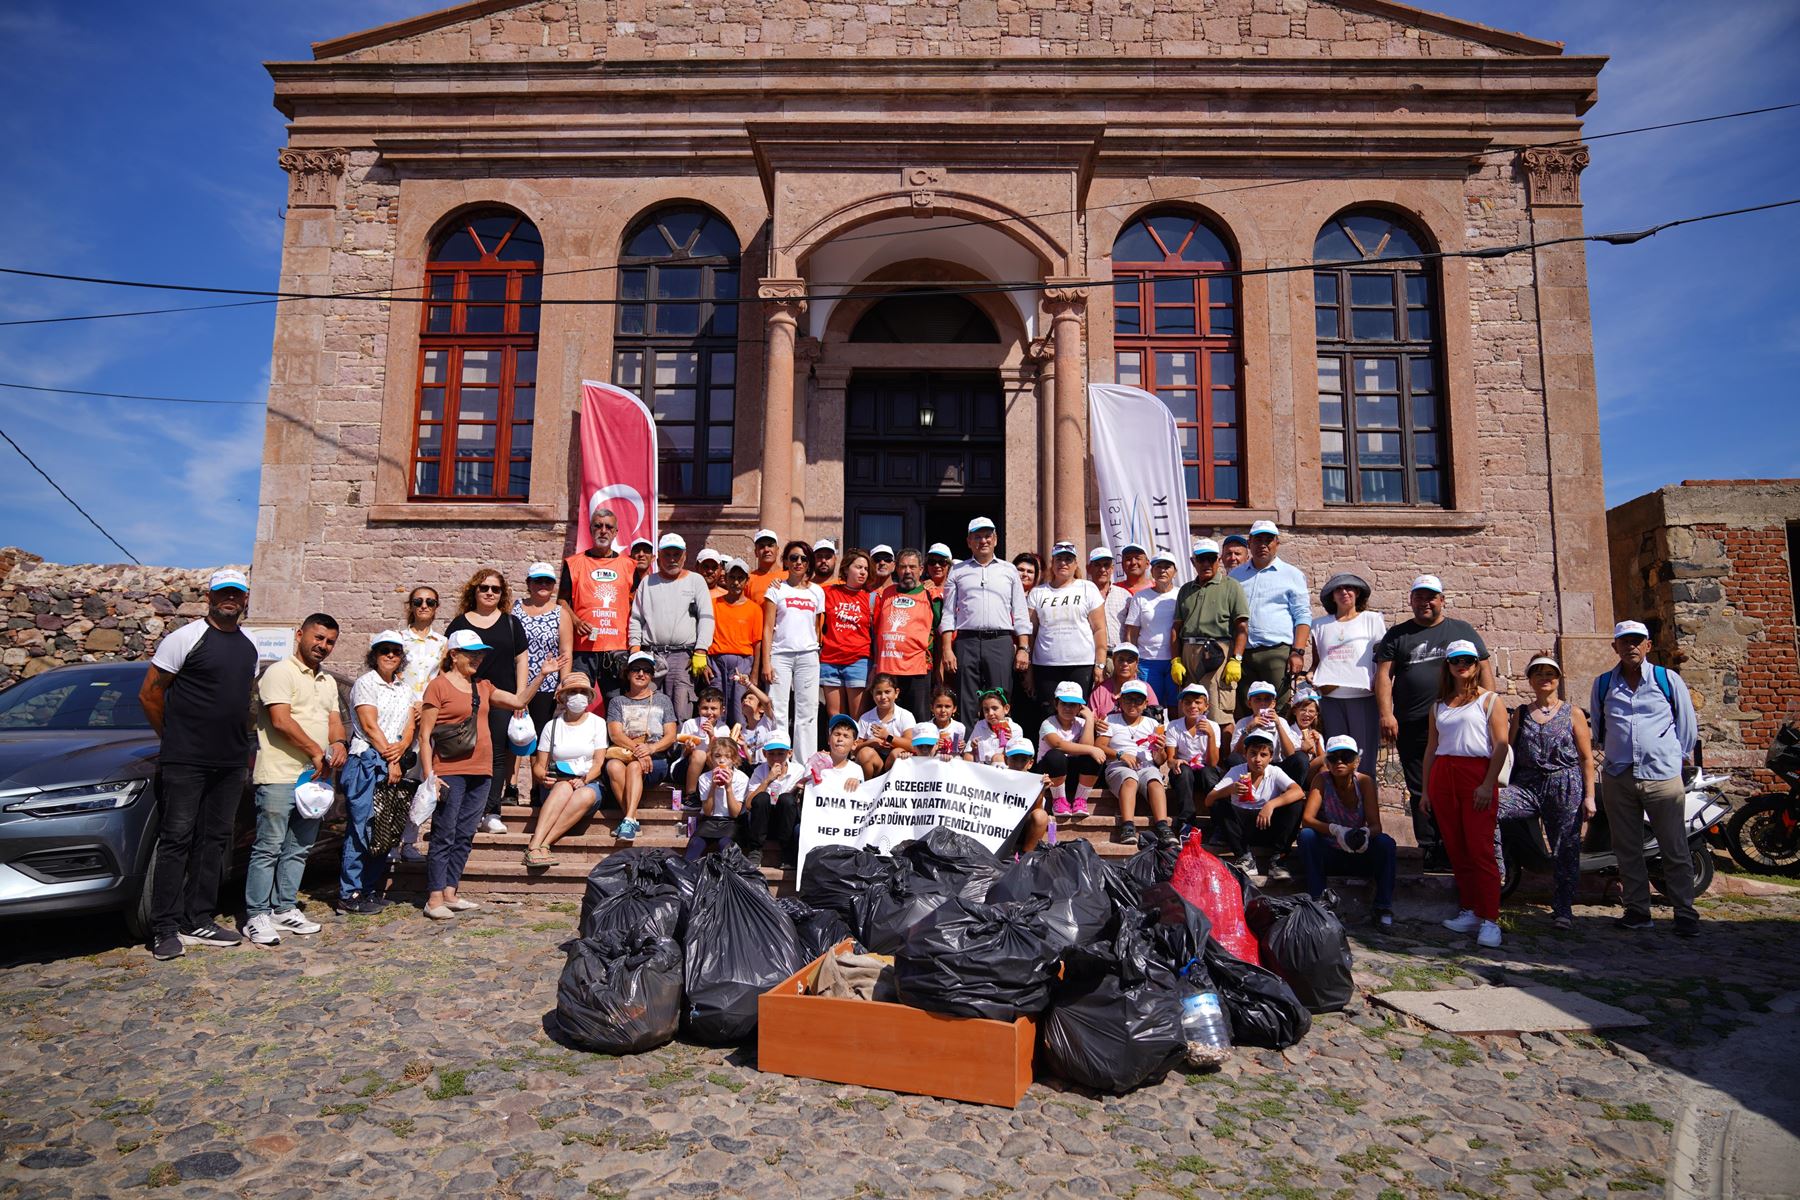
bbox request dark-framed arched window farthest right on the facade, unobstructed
[1312,210,1451,506]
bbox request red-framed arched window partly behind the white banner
[1112,212,1244,504]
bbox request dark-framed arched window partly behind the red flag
[612,205,738,500]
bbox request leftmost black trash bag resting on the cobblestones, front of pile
[556,932,682,1054]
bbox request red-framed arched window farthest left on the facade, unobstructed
[412,209,544,500]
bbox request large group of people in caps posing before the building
[130,504,1697,957]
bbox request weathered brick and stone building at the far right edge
[1606,479,1800,788]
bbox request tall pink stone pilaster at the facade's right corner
[1523,146,1613,678]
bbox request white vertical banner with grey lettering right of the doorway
[1087,383,1193,583]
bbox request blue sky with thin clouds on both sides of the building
[0,0,1800,565]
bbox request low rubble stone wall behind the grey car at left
[0,547,247,689]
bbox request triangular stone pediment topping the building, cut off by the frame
[313,0,1562,63]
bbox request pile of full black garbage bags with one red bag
[558,828,1352,1094]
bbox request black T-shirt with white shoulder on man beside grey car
[151,621,256,766]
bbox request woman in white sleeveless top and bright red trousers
[1426,640,1508,950]
